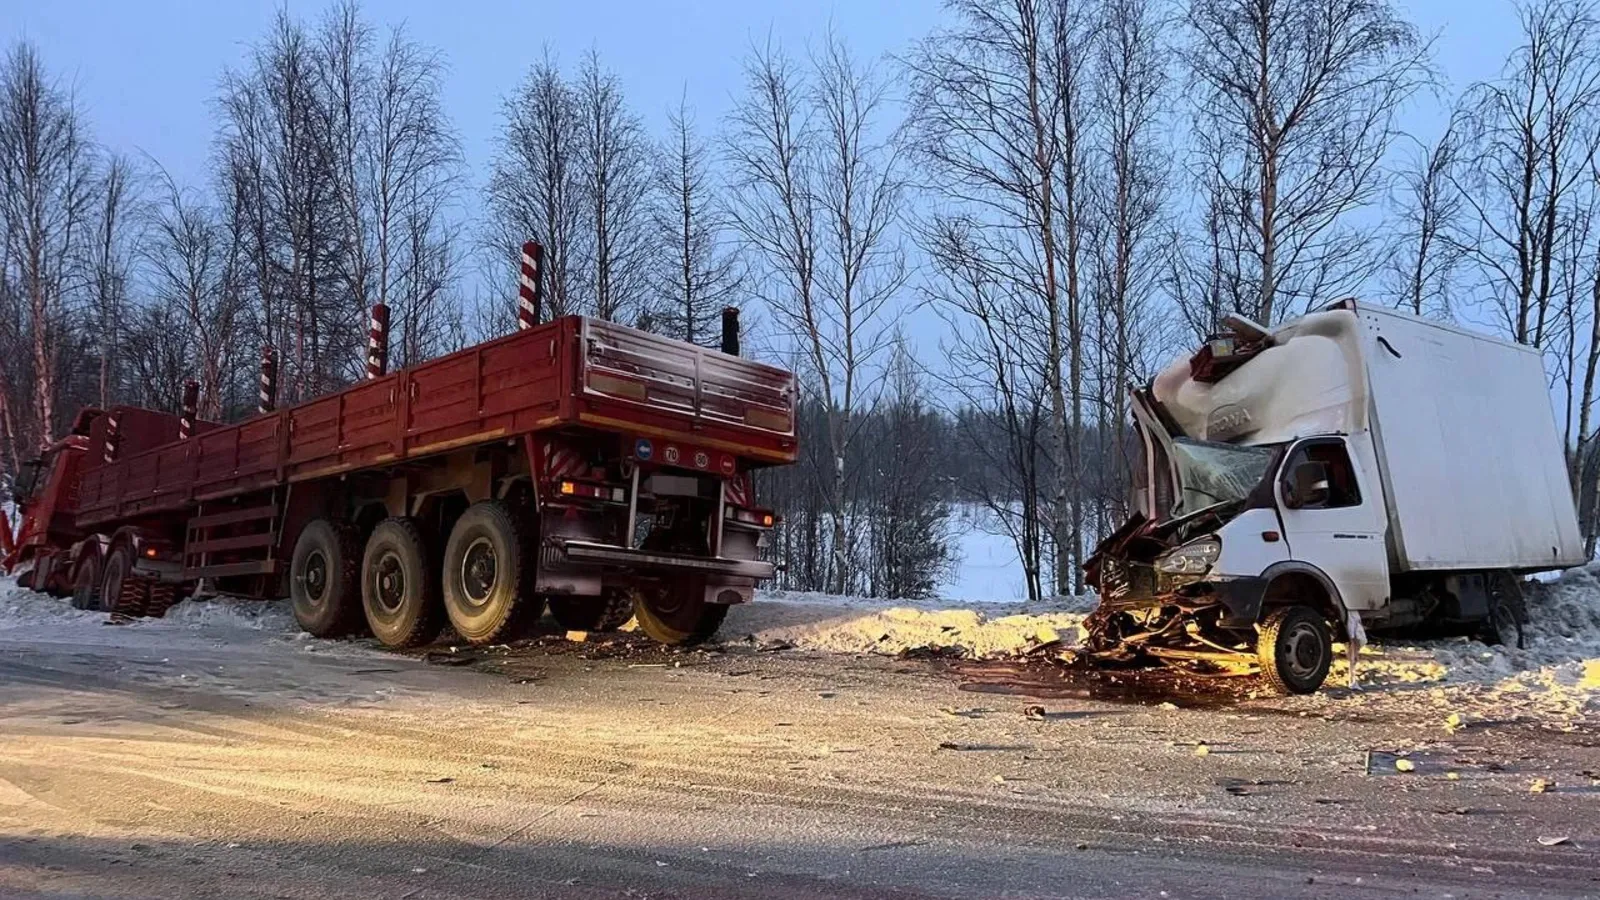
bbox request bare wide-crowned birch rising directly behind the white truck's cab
[1184,0,1429,325]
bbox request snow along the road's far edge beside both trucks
[0,564,1600,724]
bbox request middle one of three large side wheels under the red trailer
[362,519,443,647]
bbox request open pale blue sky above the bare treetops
[0,0,1515,196]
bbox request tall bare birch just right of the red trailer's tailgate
[726,35,907,593]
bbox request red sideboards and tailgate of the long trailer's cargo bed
[77,315,797,527]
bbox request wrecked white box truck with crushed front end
[1083,299,1584,693]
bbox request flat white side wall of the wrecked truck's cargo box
[1355,304,1584,572]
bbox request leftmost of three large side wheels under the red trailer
[290,519,362,637]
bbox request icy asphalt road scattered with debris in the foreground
[0,611,1600,900]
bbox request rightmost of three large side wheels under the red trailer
[443,500,542,644]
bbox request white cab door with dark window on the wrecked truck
[1277,437,1389,610]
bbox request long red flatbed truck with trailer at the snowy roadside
[6,315,797,647]
